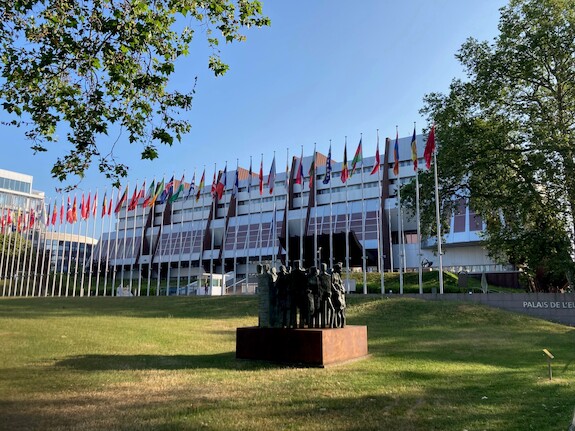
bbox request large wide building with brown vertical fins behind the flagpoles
[93,136,508,289]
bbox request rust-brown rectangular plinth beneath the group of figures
[236,326,368,367]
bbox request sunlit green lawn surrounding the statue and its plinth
[0,295,575,431]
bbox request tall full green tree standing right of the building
[406,0,575,290]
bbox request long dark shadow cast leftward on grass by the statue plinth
[55,352,286,371]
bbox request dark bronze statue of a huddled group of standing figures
[258,261,345,328]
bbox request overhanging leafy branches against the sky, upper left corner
[0,0,269,189]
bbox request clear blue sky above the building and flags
[0,0,506,198]
